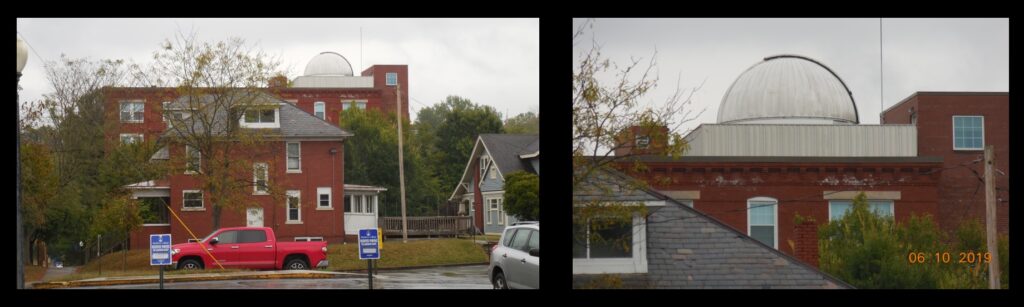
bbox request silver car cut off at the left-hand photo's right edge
[487,222,541,289]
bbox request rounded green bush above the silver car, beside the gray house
[505,171,541,220]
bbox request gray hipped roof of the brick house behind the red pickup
[164,91,353,138]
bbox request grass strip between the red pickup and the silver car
[328,238,487,270]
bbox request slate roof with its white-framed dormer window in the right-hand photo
[572,171,852,289]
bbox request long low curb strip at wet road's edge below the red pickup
[32,270,367,289]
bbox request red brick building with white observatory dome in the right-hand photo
[593,55,1009,270]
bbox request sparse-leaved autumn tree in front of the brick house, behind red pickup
[141,34,284,229]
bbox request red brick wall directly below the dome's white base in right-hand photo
[623,162,941,258]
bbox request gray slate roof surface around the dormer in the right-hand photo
[573,166,853,289]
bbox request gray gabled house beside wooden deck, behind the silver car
[449,134,541,233]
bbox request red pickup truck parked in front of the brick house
[171,227,328,270]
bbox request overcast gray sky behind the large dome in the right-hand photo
[572,18,1010,129]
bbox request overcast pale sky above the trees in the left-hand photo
[17,18,540,121]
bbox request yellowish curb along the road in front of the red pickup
[32,271,361,289]
